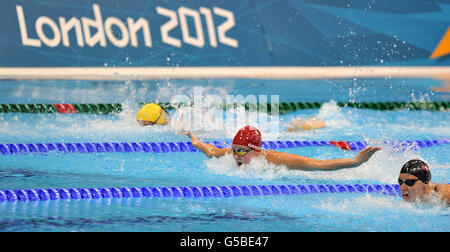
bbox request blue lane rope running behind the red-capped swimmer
[0,139,450,155]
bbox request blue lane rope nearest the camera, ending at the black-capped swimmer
[0,184,400,202]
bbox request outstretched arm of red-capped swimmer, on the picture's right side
[266,147,381,171]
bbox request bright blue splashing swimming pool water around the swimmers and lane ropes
[0,78,450,231]
